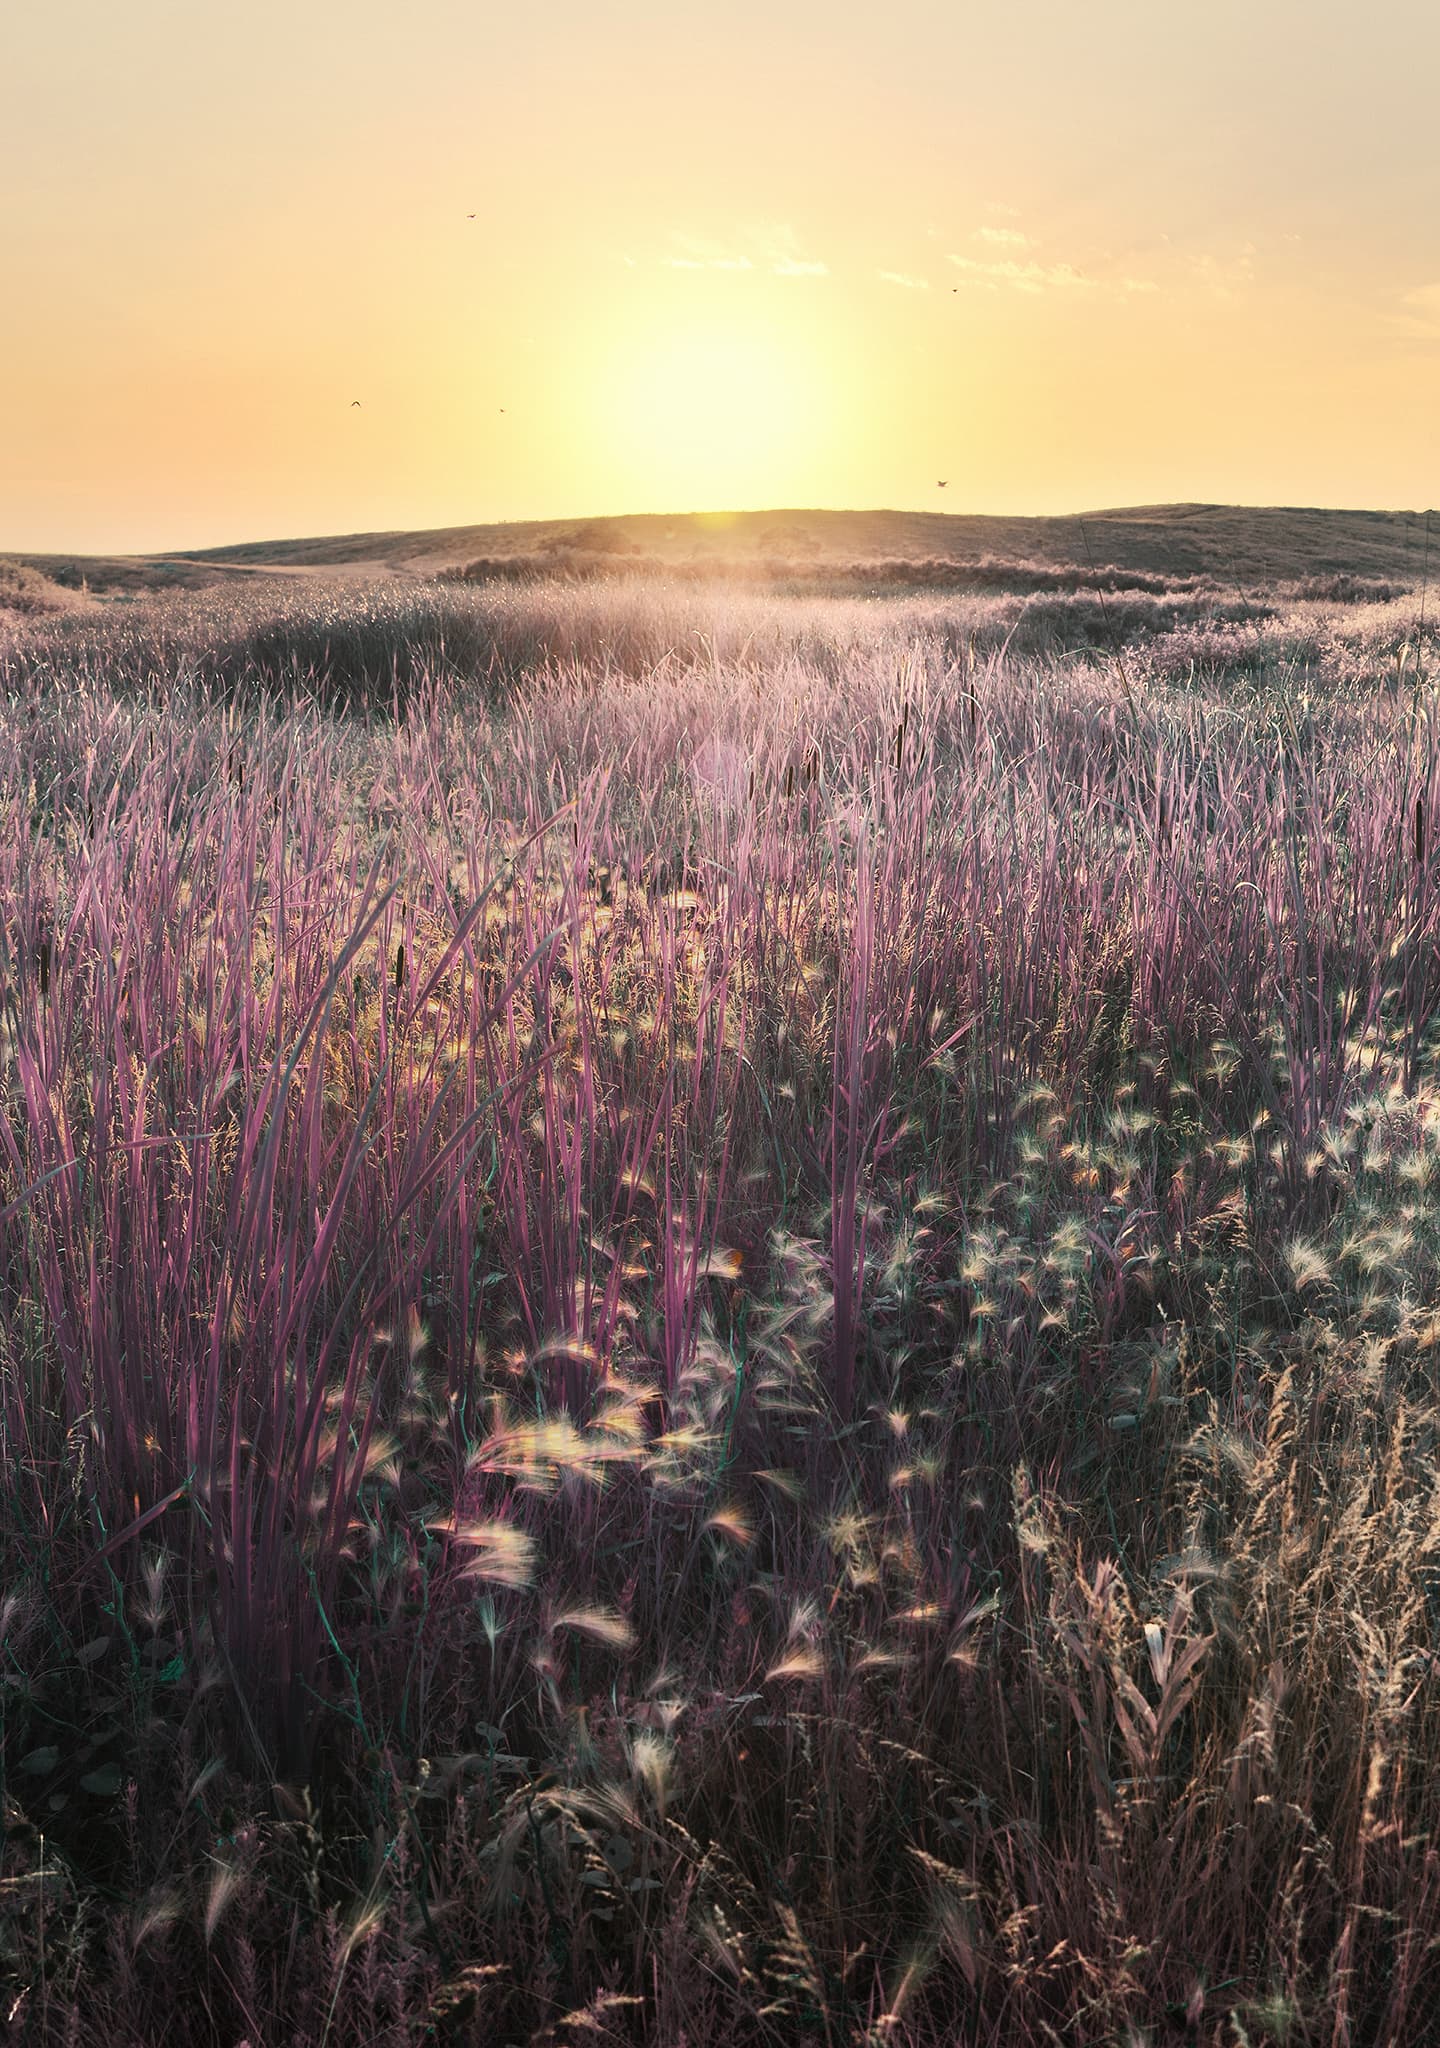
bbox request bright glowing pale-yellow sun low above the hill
[594,319,830,510]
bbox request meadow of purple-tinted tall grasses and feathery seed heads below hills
[0,559,1440,2048]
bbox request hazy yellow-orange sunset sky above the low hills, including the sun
[0,0,1440,551]
